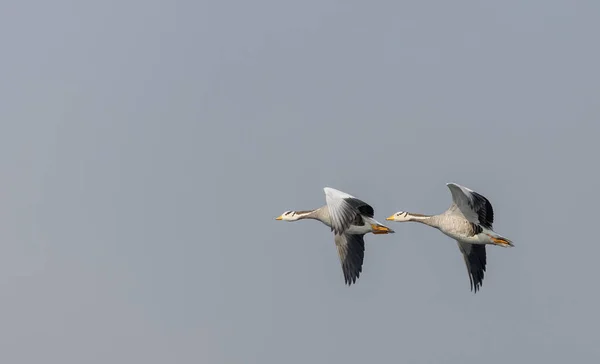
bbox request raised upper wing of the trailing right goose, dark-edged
[446,183,494,230]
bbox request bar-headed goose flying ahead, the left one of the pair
[275,187,394,285]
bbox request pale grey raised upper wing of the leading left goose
[323,187,375,235]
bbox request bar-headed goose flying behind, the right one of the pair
[386,183,514,293]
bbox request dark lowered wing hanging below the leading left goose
[335,234,365,285]
